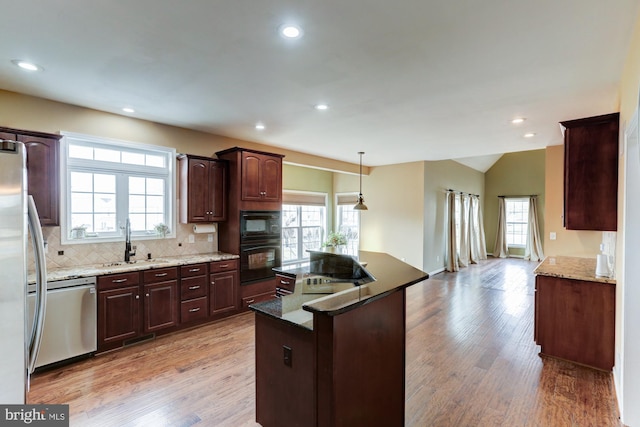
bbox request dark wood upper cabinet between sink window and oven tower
[179,155,227,223]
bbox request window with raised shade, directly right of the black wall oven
[282,191,327,263]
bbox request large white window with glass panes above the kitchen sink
[61,133,175,243]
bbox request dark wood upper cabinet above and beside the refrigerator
[0,127,61,226]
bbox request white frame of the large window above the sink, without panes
[60,132,177,245]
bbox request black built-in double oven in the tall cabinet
[240,211,282,285]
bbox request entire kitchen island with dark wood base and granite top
[250,251,429,427]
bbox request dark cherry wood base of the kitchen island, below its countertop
[255,289,405,427]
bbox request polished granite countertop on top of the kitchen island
[249,251,429,330]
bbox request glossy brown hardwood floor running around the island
[28,259,622,427]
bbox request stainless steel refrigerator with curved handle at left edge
[0,140,47,404]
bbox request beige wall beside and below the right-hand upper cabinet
[544,145,602,257]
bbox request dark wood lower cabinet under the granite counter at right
[534,275,616,371]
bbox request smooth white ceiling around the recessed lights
[0,0,638,169]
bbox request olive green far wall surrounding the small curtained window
[484,150,546,256]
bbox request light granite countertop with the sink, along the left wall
[28,252,240,283]
